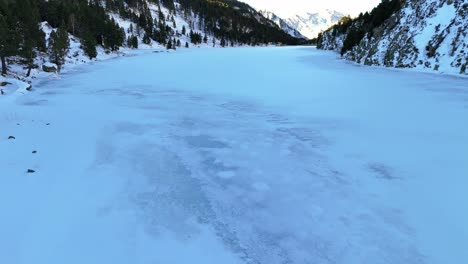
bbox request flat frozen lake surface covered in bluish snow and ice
[0,48,468,264]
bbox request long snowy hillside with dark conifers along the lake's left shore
[0,0,299,79]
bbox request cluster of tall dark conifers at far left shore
[0,0,125,75]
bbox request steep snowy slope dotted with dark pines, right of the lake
[317,0,468,74]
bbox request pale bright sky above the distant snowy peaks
[241,0,381,16]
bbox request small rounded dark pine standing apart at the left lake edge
[49,23,70,71]
